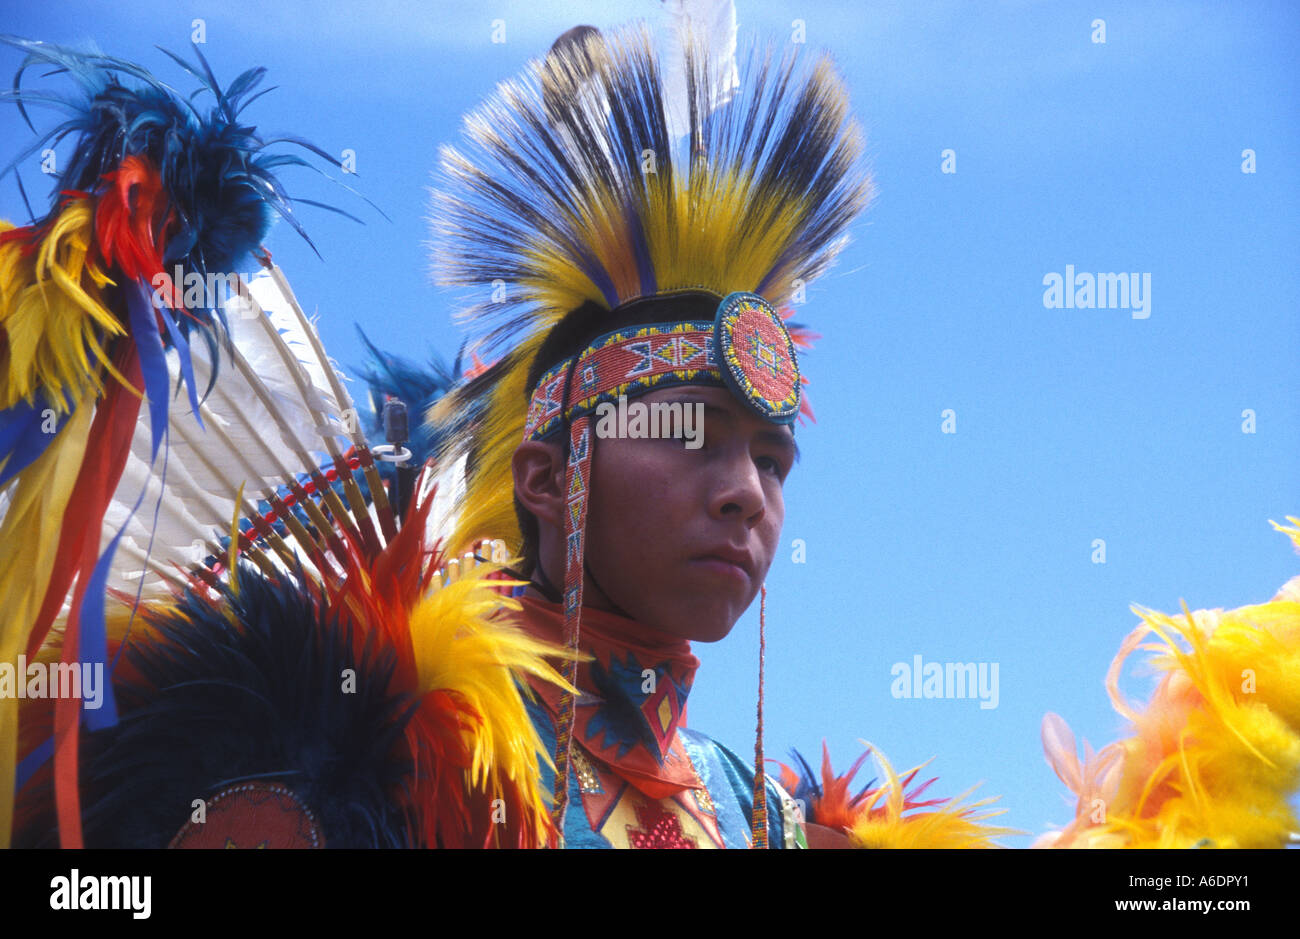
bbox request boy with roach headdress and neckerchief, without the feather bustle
[434,23,866,848]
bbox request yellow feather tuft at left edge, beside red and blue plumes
[0,199,126,414]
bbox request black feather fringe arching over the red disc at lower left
[19,567,416,848]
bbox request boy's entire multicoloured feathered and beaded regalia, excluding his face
[0,12,1300,848]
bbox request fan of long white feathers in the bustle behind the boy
[101,273,355,600]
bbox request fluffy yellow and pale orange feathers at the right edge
[1035,518,1300,848]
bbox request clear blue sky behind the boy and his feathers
[0,0,1300,845]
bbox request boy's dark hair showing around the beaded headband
[515,290,720,577]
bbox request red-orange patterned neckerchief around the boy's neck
[519,596,703,799]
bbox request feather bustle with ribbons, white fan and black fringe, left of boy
[0,32,562,847]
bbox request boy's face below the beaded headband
[577,385,796,642]
